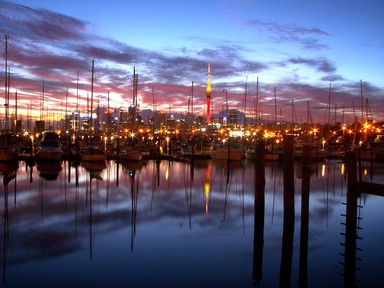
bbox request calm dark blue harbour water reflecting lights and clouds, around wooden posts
[0,161,384,287]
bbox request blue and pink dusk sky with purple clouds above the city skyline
[0,0,384,123]
